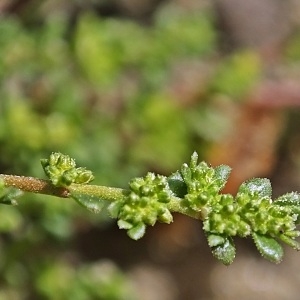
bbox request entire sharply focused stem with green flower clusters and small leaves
[0,153,300,265]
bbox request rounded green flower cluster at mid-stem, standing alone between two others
[108,173,173,240]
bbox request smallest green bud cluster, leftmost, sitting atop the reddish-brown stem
[41,152,94,187]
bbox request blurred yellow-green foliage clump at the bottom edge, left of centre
[37,261,136,300]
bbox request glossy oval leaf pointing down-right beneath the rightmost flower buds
[252,232,283,263]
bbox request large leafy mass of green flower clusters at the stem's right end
[177,153,300,264]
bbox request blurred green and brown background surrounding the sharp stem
[0,0,300,300]
